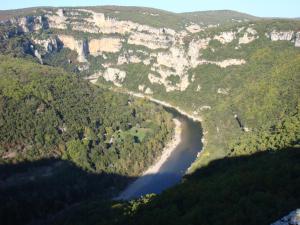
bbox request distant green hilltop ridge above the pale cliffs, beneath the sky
[0,6,257,30]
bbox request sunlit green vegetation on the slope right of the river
[124,21,300,168]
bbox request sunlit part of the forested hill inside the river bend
[0,56,173,175]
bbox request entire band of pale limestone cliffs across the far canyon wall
[5,8,300,94]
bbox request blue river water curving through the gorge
[117,107,202,200]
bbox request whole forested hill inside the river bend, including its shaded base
[0,56,173,224]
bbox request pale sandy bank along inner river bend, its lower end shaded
[115,118,182,200]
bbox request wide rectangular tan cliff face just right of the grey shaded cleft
[89,38,122,56]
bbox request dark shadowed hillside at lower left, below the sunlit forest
[0,159,133,225]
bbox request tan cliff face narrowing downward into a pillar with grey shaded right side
[58,35,88,63]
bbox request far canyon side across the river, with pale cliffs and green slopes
[2,6,300,172]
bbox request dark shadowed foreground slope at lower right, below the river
[55,148,300,225]
